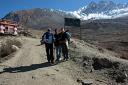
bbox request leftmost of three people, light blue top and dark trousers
[42,28,55,64]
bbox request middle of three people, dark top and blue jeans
[54,29,61,62]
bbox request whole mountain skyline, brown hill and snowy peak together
[3,1,128,28]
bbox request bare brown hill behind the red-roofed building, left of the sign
[3,8,71,29]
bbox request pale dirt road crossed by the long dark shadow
[0,38,79,85]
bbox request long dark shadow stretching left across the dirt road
[2,62,52,73]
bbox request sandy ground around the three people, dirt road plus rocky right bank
[0,36,128,85]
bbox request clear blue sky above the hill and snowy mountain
[0,0,128,18]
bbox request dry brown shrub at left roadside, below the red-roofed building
[0,39,22,58]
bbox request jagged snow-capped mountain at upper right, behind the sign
[70,1,128,20]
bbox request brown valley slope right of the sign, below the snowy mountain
[81,16,128,59]
